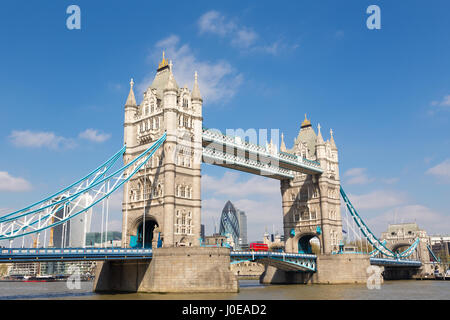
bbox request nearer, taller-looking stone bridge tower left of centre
[122,53,203,247]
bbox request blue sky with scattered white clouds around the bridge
[0,0,450,245]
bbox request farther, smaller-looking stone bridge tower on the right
[280,115,342,254]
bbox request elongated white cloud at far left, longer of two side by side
[9,130,75,149]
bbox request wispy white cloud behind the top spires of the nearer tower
[138,35,243,103]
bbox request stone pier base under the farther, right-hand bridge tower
[259,254,370,284]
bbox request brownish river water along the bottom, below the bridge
[0,280,450,300]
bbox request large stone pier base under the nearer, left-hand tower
[94,247,239,293]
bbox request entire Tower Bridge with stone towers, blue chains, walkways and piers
[0,56,429,292]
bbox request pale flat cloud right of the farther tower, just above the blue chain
[348,190,407,210]
